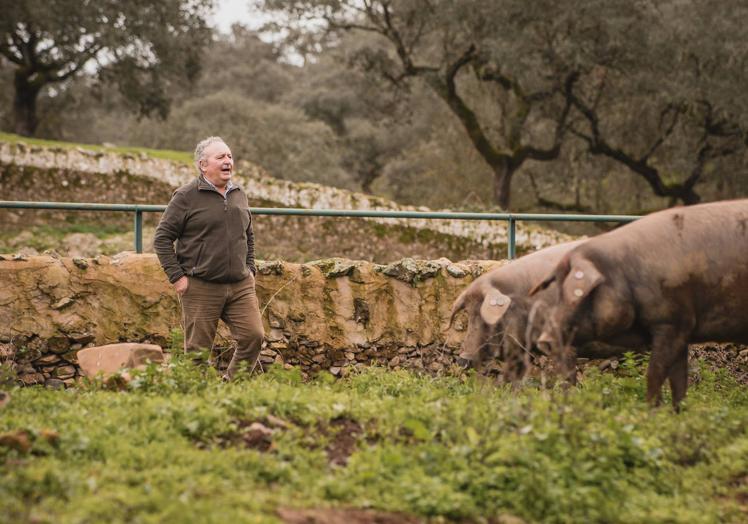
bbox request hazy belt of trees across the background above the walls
[0,0,748,213]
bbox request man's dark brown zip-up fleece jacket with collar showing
[153,175,257,284]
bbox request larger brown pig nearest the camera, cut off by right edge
[530,200,748,410]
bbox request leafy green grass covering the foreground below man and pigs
[0,350,748,523]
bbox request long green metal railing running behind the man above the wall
[0,200,640,260]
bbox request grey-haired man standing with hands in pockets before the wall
[153,136,264,380]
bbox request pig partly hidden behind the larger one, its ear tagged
[449,240,583,374]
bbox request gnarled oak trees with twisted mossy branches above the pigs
[265,0,748,208]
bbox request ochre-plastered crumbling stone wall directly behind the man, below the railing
[0,254,501,386]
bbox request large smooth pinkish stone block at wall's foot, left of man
[78,343,164,377]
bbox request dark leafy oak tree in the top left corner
[0,0,212,135]
